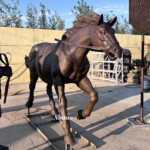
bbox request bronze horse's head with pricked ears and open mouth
[91,15,122,60]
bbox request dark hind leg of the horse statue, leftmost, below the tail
[26,71,38,108]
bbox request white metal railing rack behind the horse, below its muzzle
[92,53,123,84]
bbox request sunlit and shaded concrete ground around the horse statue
[0,80,150,150]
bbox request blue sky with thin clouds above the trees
[12,0,129,28]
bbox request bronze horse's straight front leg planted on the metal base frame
[54,77,74,145]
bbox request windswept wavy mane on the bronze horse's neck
[64,11,100,38]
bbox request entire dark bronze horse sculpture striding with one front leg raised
[26,11,122,144]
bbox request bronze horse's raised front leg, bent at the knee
[77,77,98,119]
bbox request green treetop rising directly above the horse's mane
[71,0,93,19]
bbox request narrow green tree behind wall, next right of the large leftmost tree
[26,4,38,28]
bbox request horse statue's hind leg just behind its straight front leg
[47,84,58,119]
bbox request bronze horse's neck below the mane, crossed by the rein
[68,27,91,62]
